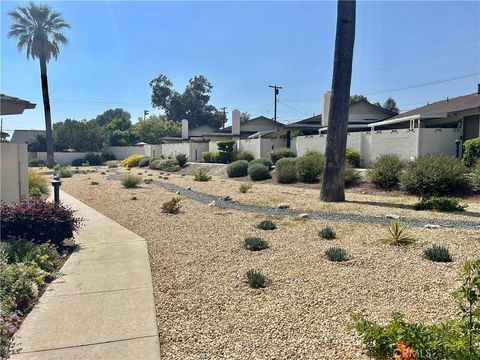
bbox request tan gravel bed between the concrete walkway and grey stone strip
[62,169,480,360]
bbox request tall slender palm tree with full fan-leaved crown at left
[8,3,70,168]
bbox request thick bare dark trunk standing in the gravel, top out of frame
[320,0,356,202]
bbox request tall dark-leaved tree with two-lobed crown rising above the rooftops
[150,75,224,128]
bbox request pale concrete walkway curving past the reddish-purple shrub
[12,192,160,360]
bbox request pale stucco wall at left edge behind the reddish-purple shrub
[0,143,28,203]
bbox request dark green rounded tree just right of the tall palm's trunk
[53,119,103,152]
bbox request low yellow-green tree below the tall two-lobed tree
[132,115,182,144]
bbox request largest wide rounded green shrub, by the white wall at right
[400,154,469,198]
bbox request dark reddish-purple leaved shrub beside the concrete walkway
[0,199,82,246]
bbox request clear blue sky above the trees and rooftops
[0,1,480,130]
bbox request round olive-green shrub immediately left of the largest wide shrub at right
[367,154,405,189]
